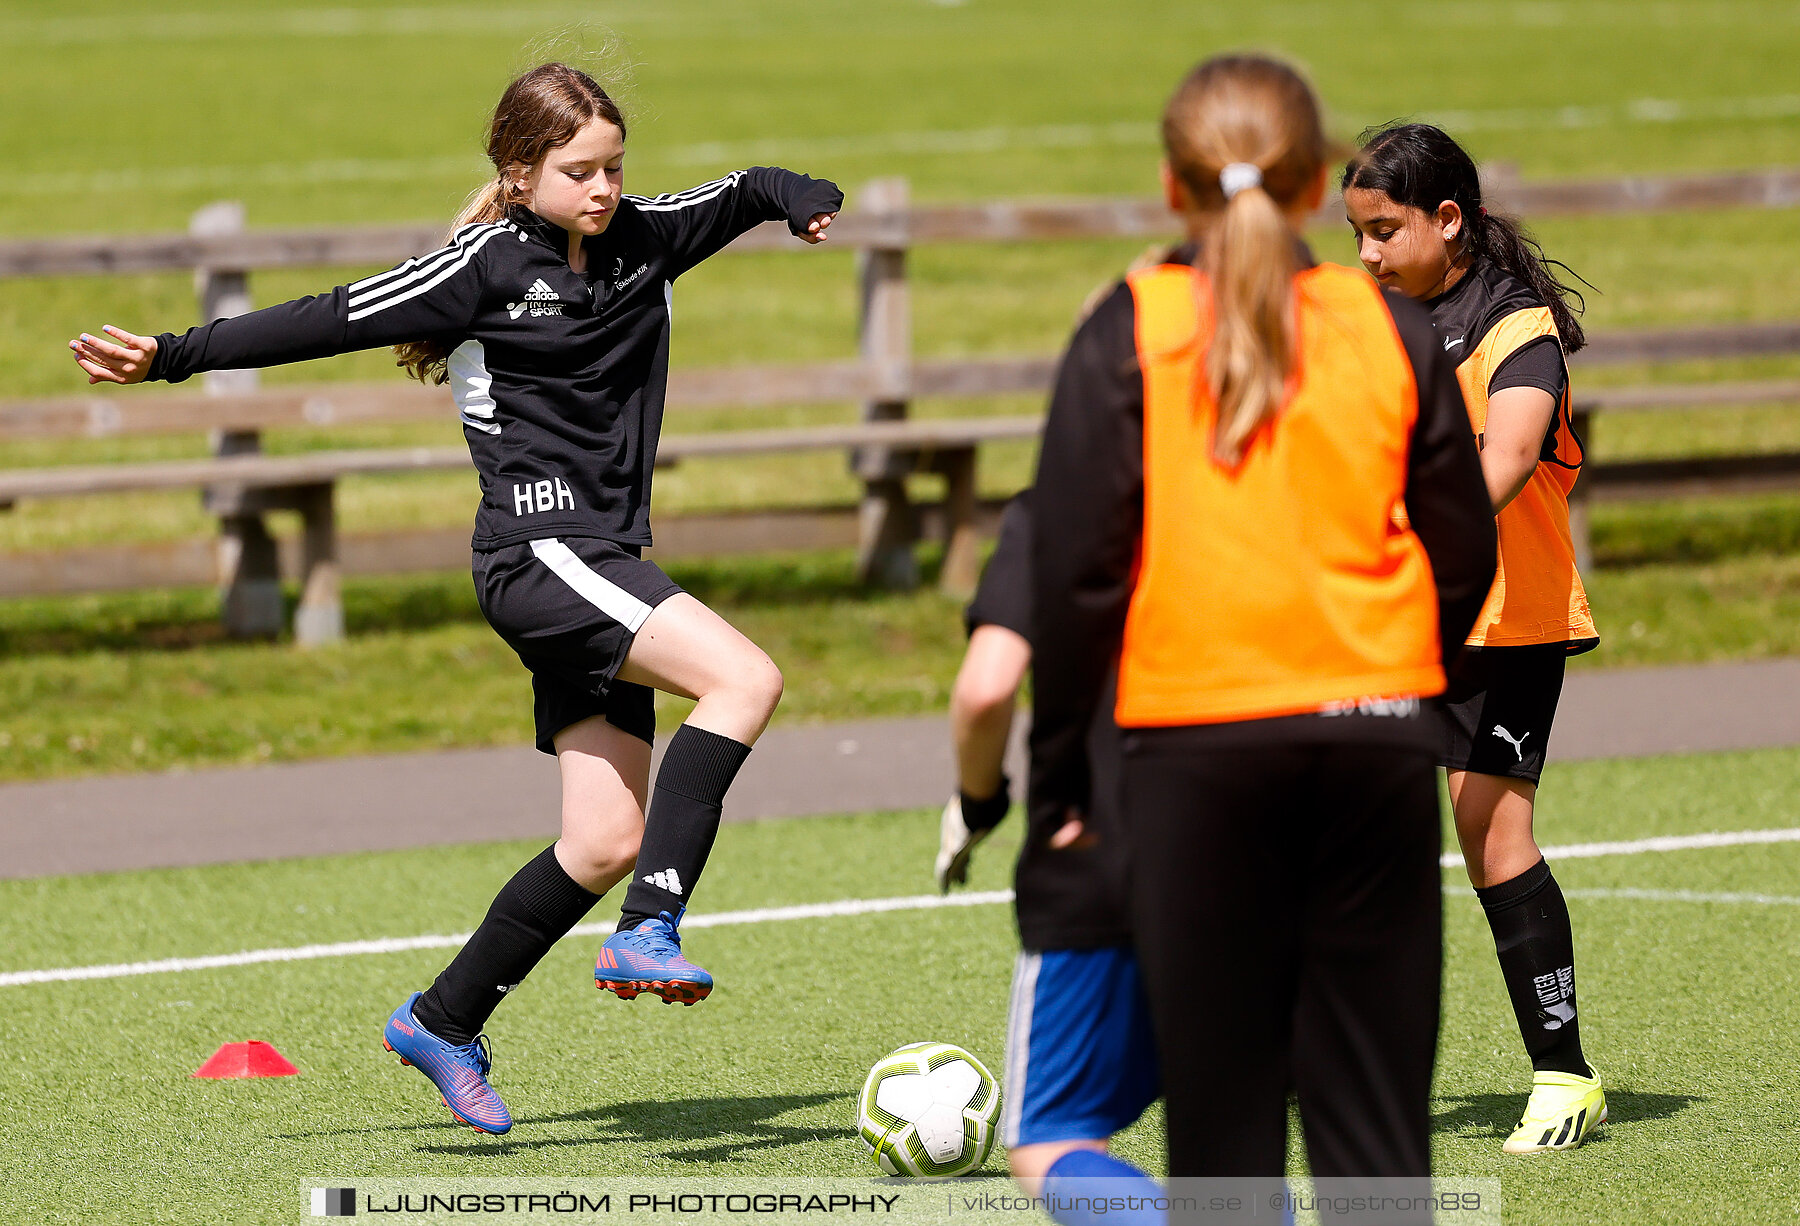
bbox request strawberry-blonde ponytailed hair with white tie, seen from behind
[1163,56,1327,466]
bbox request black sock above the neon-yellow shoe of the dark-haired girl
[1474,861,1593,1077]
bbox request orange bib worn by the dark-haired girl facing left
[1456,306,1598,648]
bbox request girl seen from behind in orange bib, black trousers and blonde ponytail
[1030,56,1494,1188]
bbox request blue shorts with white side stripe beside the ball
[1001,945,1163,1149]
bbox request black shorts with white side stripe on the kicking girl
[473,536,680,754]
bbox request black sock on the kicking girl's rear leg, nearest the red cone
[412,844,599,1044]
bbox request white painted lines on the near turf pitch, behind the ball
[0,828,1800,988]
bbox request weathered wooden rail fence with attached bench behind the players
[0,178,1800,643]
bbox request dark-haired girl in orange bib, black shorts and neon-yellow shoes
[1341,124,1606,1154]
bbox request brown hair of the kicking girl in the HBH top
[394,63,625,383]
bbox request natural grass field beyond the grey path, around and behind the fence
[0,0,1800,778]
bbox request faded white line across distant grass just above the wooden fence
[14,94,1800,196]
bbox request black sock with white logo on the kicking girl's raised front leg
[619,724,751,933]
